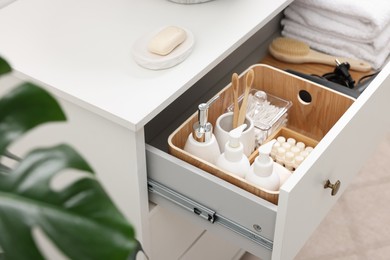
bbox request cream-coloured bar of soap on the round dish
[148,26,187,56]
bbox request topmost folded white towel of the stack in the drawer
[291,0,390,35]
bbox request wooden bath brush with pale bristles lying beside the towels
[268,37,371,72]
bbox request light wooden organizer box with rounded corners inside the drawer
[168,64,354,204]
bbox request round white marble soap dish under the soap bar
[132,28,194,70]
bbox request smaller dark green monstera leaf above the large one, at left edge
[0,82,66,155]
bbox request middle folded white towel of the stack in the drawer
[285,2,390,50]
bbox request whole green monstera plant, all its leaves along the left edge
[0,65,142,259]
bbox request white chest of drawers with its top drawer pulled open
[0,0,390,259]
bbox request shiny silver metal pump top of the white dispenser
[192,96,219,143]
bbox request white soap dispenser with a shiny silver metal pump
[184,96,221,164]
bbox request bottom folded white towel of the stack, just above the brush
[281,19,390,69]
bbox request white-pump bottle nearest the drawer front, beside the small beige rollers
[246,140,290,191]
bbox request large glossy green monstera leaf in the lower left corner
[0,145,140,259]
